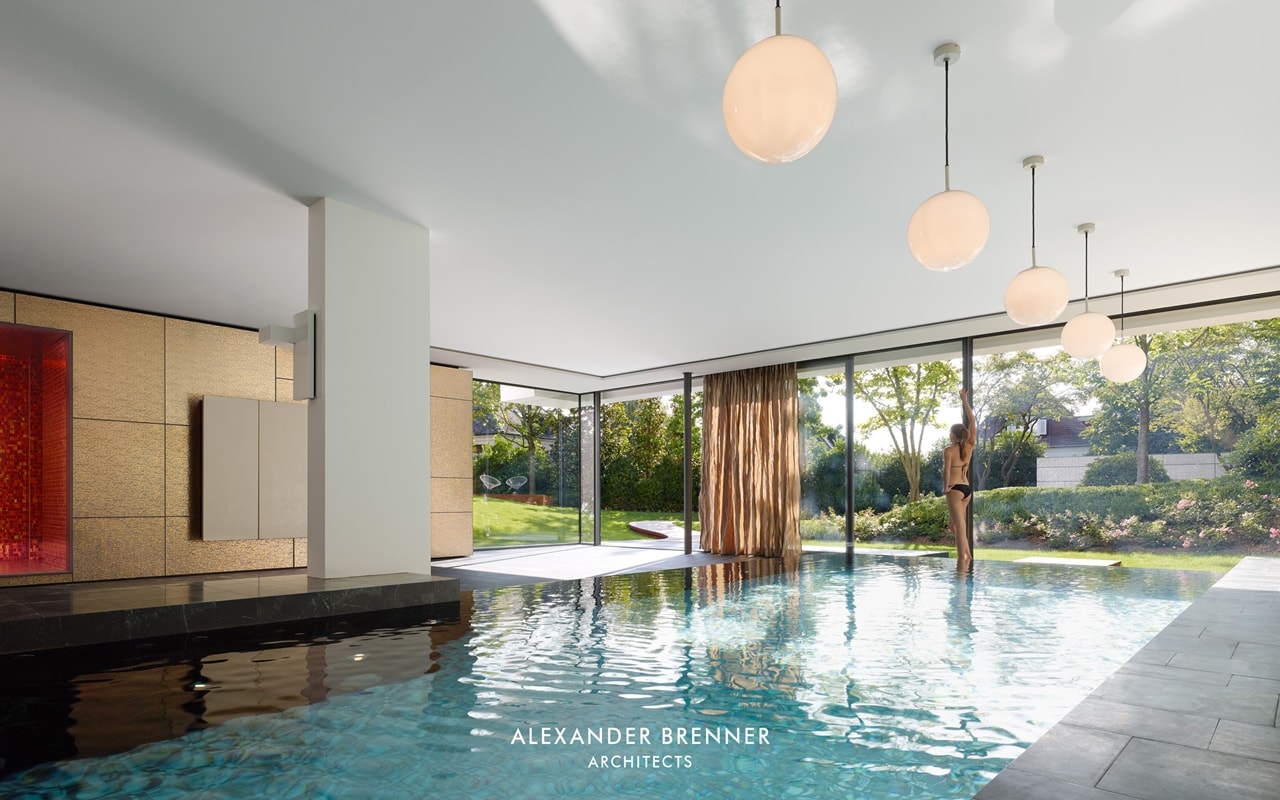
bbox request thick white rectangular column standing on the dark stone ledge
[307,198,431,577]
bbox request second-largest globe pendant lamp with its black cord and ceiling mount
[906,44,991,273]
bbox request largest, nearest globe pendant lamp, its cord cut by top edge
[722,0,837,164]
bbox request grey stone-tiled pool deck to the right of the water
[977,558,1280,800]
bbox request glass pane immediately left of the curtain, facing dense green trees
[600,384,703,549]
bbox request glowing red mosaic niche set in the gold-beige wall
[0,324,72,576]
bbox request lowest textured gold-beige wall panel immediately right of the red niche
[72,517,165,581]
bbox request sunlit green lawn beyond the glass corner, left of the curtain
[471,497,698,548]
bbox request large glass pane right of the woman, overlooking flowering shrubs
[974,306,1280,566]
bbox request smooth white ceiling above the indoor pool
[0,0,1280,386]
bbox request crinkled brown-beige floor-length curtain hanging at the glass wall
[699,364,800,557]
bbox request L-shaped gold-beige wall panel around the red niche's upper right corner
[15,294,165,422]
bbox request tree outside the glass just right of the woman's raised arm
[974,351,1084,489]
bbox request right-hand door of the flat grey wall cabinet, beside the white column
[257,402,307,539]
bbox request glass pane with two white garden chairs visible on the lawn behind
[472,380,581,548]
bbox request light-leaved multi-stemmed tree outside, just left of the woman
[852,361,960,503]
